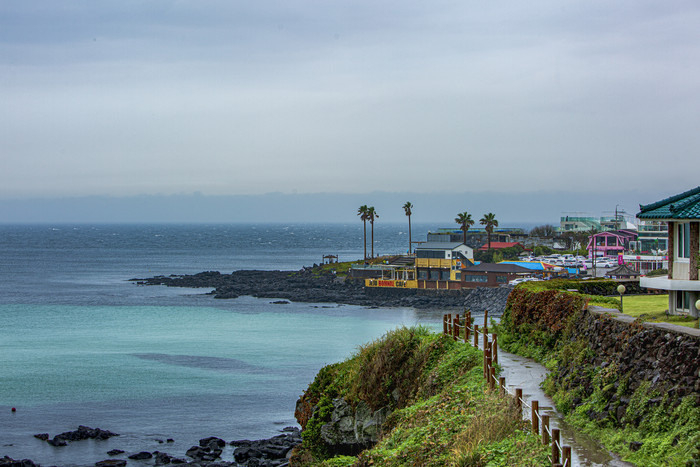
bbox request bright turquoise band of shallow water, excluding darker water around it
[0,298,416,406]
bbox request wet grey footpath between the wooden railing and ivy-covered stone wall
[498,349,634,467]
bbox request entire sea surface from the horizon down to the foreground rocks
[0,225,441,465]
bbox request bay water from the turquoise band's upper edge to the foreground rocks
[0,297,430,465]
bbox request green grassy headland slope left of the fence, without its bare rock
[293,328,548,466]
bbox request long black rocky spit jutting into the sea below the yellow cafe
[131,268,512,314]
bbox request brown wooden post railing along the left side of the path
[442,311,572,467]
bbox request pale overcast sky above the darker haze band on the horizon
[0,0,700,205]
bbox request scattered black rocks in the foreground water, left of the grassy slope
[0,425,301,467]
